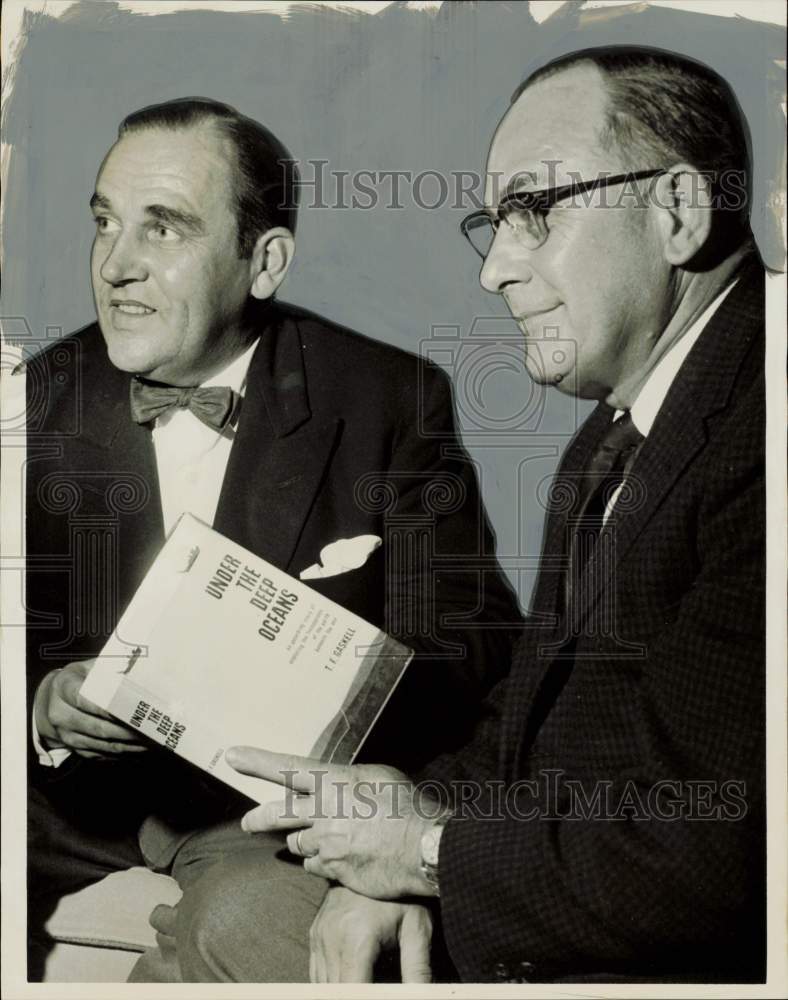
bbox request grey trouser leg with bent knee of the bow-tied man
[129,819,328,983]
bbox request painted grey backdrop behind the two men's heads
[2,0,784,603]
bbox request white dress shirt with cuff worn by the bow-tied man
[32,338,259,767]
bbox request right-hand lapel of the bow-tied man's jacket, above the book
[214,307,339,569]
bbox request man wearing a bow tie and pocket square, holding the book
[27,99,518,979]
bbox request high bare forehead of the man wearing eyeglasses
[485,63,612,204]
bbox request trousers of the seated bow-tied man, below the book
[28,776,328,982]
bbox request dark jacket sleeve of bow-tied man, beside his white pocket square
[360,364,522,773]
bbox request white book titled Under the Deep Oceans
[81,514,413,802]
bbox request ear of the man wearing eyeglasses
[652,163,713,267]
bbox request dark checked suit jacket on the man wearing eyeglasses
[426,267,765,982]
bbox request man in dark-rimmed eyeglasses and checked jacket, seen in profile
[183,48,765,982]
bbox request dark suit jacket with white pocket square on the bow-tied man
[27,305,522,818]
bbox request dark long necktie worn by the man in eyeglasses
[564,412,645,607]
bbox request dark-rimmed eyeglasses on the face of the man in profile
[460,168,665,258]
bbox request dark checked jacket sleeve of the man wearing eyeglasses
[440,392,765,982]
